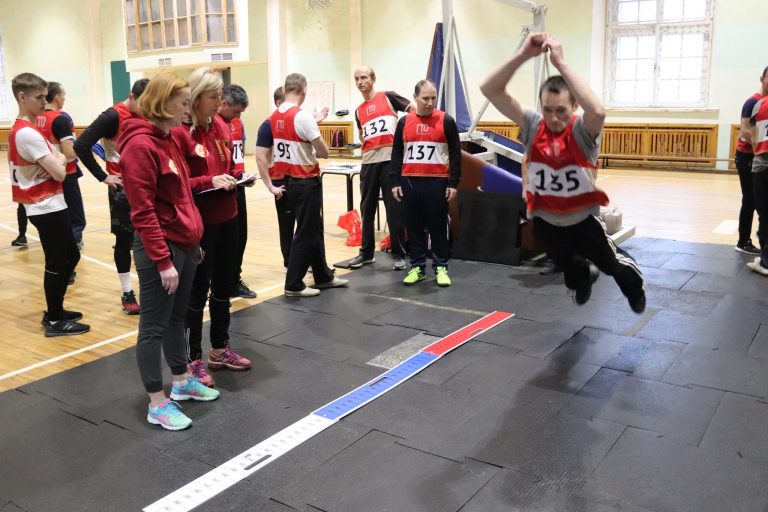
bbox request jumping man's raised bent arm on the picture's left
[480,32,547,126]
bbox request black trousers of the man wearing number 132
[360,160,405,259]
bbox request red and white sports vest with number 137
[402,110,450,178]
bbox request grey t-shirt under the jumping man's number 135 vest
[519,108,603,226]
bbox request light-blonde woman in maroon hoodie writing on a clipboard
[173,67,251,386]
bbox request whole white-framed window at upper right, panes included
[605,0,714,107]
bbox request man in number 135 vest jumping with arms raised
[480,33,645,313]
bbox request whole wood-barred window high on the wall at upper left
[123,0,237,53]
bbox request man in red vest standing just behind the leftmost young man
[37,82,85,260]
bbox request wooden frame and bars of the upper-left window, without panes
[122,0,239,55]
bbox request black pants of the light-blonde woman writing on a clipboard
[186,217,240,361]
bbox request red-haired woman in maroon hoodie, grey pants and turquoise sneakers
[118,73,219,430]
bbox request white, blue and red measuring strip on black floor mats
[144,311,514,512]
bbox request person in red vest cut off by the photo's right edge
[747,96,768,276]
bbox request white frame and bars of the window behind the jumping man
[603,0,715,109]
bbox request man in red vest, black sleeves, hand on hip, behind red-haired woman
[75,78,149,315]
